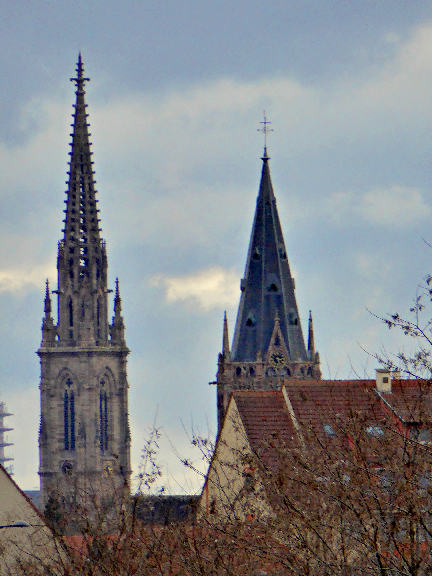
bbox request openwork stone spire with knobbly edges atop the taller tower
[57,54,109,346]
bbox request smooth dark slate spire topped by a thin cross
[231,146,308,362]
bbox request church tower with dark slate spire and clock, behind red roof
[215,145,321,430]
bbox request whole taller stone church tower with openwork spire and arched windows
[38,55,131,510]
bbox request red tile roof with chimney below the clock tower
[233,379,432,450]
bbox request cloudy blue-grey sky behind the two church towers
[0,0,432,493]
